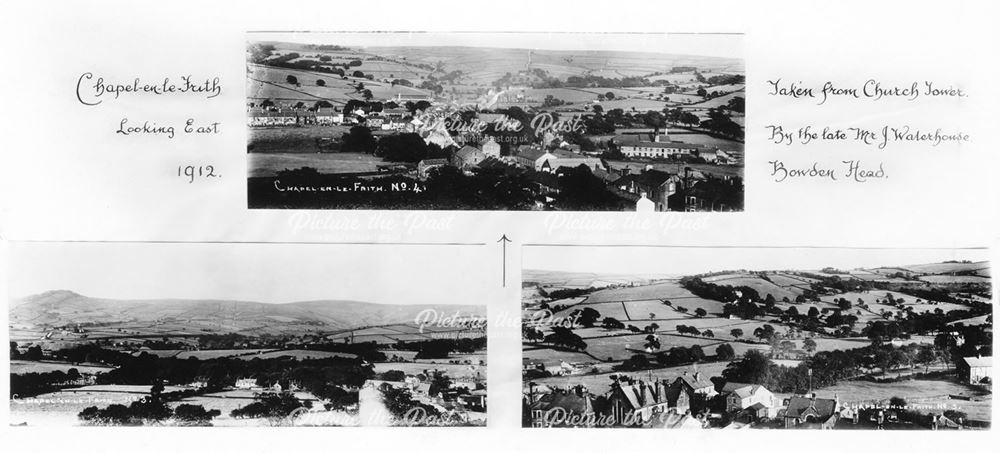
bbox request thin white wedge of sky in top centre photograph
[248,32,744,59]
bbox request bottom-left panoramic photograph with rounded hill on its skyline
[8,243,492,426]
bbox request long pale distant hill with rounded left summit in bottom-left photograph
[9,290,486,334]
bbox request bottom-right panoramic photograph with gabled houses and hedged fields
[522,246,993,430]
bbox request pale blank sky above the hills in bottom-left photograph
[8,242,492,304]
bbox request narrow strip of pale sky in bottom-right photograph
[522,246,989,275]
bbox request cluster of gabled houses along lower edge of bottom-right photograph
[523,372,842,429]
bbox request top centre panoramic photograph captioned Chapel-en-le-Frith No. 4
[246,32,746,212]
